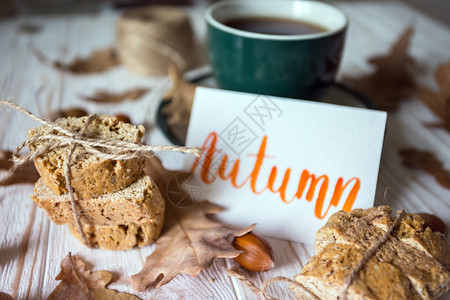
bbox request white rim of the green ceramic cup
[205,0,348,41]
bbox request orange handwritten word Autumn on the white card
[191,132,361,219]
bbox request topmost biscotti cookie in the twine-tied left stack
[28,116,145,199]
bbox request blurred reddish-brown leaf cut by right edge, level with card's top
[418,62,450,132]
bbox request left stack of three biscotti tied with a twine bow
[0,100,202,250]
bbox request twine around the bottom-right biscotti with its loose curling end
[225,210,405,300]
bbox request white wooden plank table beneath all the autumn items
[0,1,450,299]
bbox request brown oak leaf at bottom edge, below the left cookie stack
[48,253,140,300]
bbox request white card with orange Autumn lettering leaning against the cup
[186,88,386,243]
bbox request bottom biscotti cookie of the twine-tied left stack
[67,219,163,250]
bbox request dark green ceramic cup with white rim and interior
[206,0,348,100]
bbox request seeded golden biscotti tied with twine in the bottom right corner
[291,206,450,300]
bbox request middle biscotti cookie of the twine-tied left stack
[31,175,165,225]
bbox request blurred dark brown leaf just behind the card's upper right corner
[344,27,416,111]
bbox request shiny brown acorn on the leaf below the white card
[233,232,275,272]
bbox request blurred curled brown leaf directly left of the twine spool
[31,45,119,74]
